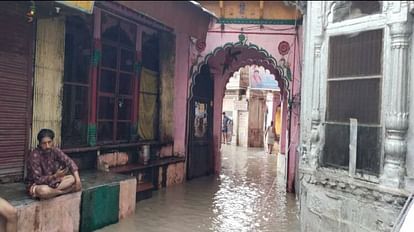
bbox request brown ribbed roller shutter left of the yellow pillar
[0,2,33,181]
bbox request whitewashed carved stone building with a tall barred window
[298,1,414,231]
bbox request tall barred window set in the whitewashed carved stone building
[323,30,383,175]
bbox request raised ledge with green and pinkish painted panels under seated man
[0,171,136,232]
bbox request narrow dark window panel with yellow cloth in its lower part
[138,32,160,140]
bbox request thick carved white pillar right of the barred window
[380,22,411,188]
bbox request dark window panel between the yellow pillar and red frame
[62,16,92,148]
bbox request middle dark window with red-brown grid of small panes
[97,14,136,144]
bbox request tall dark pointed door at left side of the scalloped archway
[187,65,214,179]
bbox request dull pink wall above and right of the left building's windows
[118,1,211,160]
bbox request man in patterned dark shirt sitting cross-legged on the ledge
[27,129,82,199]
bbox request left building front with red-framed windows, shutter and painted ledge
[0,1,217,231]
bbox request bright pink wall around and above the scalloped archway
[203,24,302,190]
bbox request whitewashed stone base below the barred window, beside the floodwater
[299,168,408,232]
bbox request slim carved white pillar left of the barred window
[305,35,323,169]
